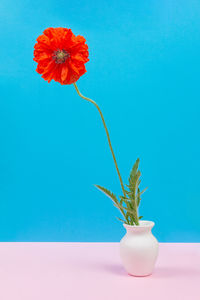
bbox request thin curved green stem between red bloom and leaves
[74,83,126,197]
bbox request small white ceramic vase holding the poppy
[120,221,158,276]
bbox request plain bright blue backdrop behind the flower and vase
[0,0,200,242]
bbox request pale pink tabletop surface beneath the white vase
[0,243,200,300]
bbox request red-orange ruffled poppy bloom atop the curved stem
[33,27,89,84]
